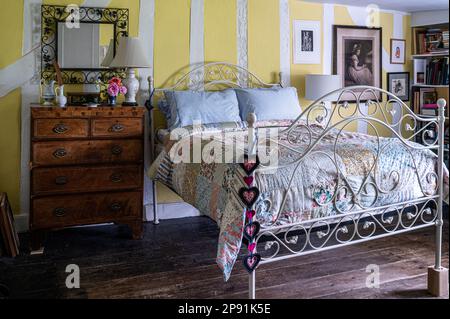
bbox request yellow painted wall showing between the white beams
[0,0,411,212]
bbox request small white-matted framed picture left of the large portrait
[294,20,322,64]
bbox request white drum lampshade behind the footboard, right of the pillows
[305,74,342,101]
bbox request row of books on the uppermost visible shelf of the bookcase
[416,29,449,54]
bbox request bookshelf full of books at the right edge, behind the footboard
[411,23,450,167]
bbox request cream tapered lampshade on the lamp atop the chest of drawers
[109,37,150,68]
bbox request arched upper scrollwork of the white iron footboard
[256,86,440,226]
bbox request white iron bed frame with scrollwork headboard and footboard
[149,62,448,299]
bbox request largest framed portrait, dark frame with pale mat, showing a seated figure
[333,25,382,102]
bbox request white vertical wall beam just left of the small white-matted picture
[280,0,291,86]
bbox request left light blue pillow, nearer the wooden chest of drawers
[169,90,241,129]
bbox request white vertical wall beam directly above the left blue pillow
[190,0,205,89]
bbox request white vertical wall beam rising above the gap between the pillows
[236,0,248,86]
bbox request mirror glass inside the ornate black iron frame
[57,22,114,69]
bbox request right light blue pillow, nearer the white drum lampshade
[235,87,302,121]
